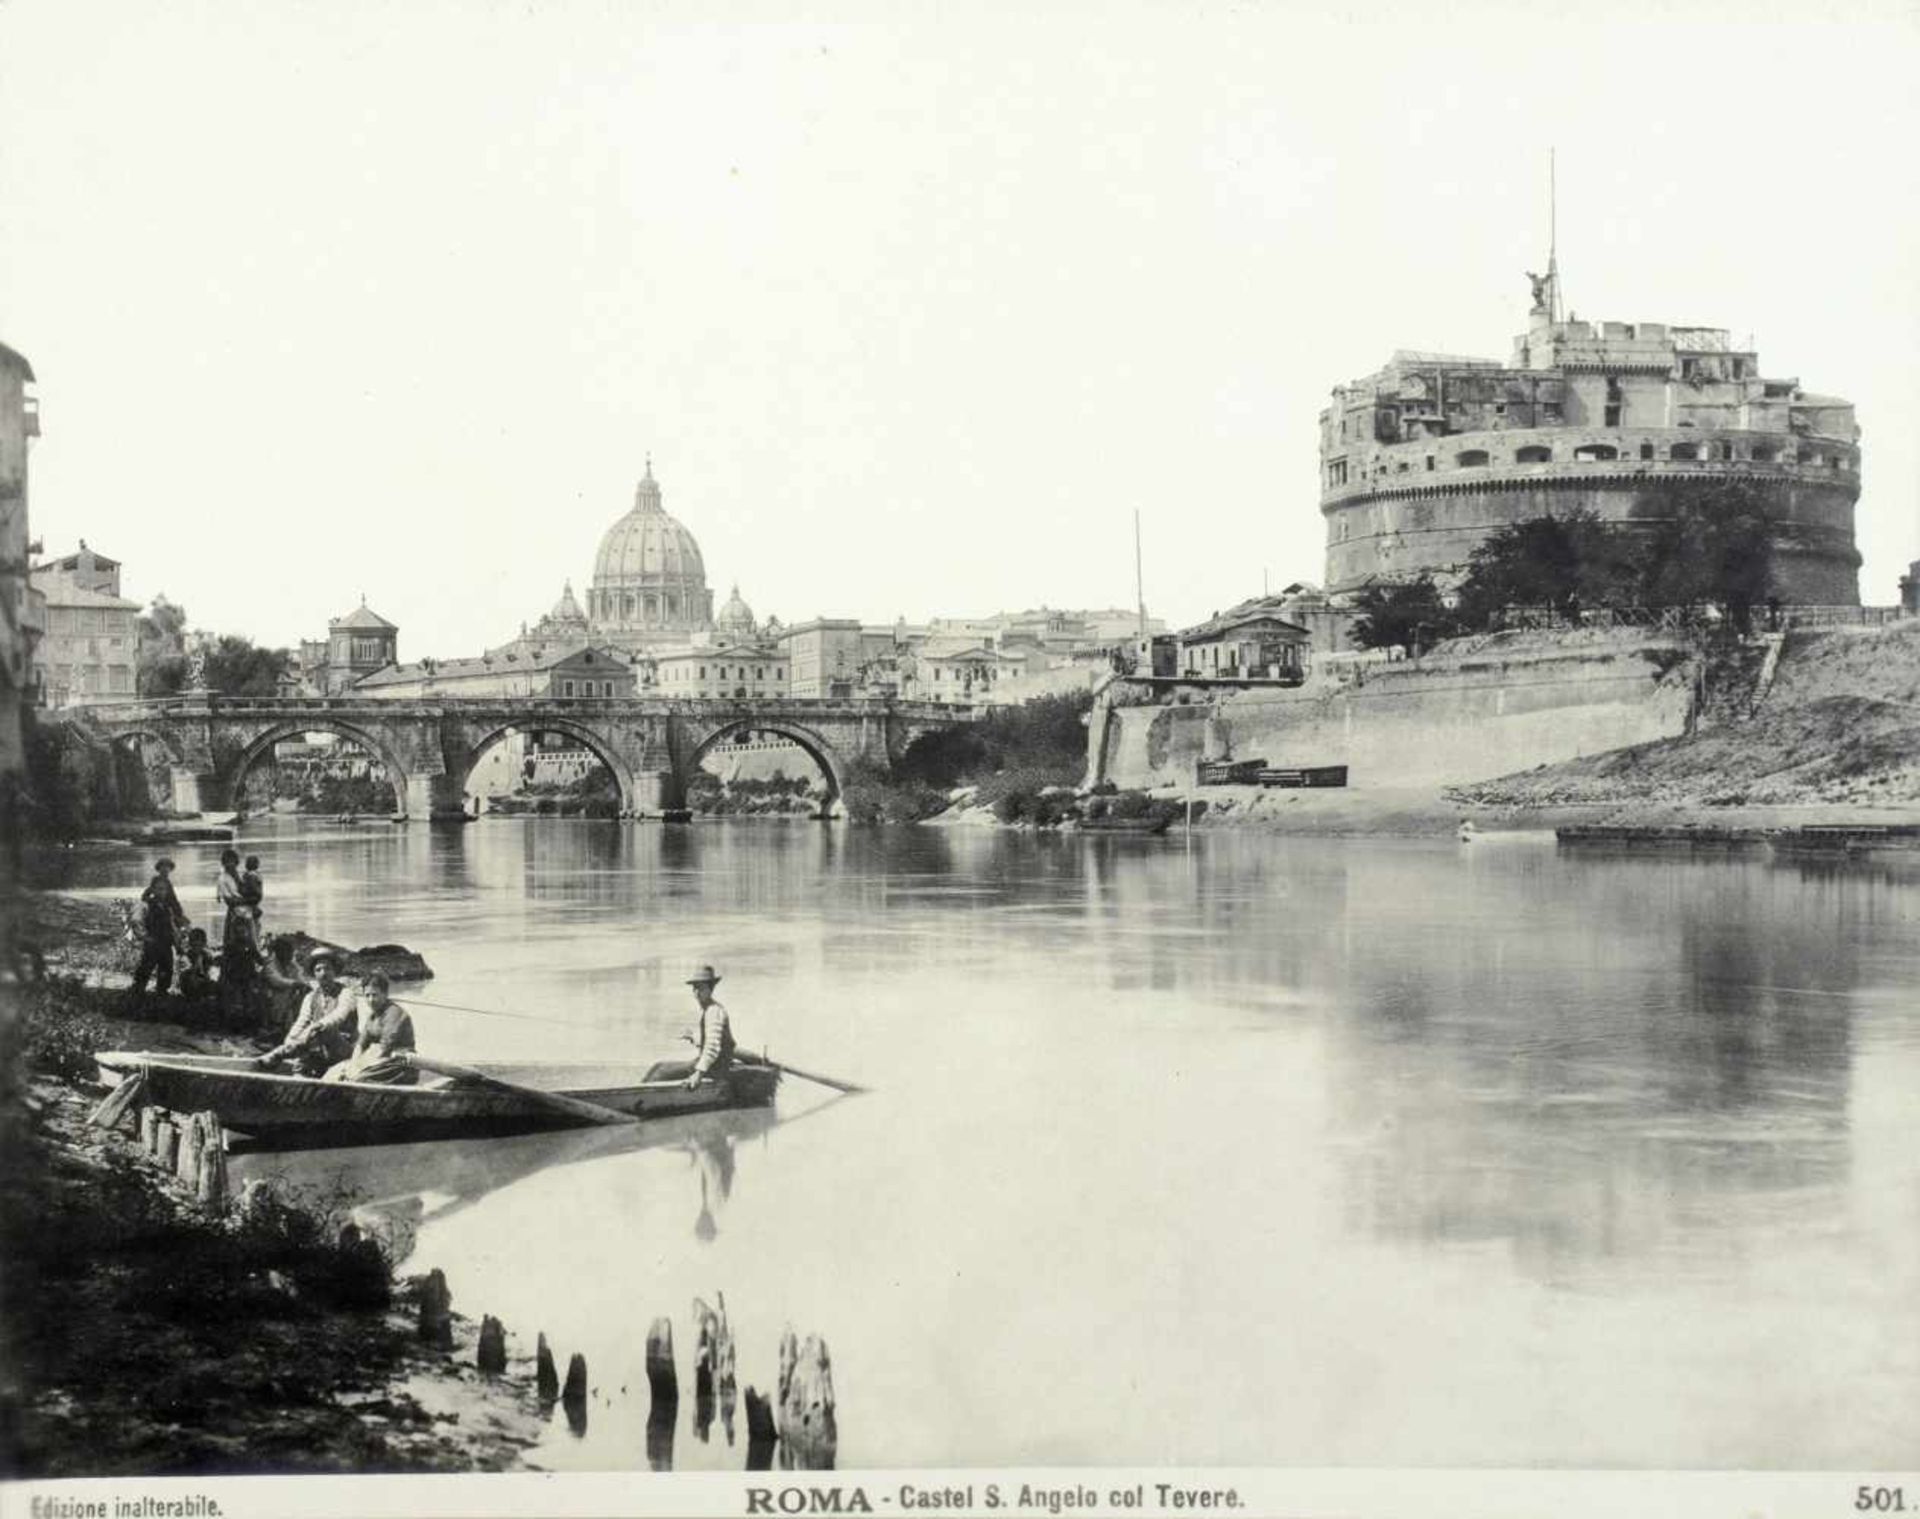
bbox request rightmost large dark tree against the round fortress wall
[1640,480,1774,634]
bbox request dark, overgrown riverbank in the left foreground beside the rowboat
[0,893,545,1477]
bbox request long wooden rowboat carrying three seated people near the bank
[94,1050,780,1145]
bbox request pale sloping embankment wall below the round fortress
[1089,645,1695,787]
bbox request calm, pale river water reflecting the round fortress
[37,820,1920,1469]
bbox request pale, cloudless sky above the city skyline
[0,0,1920,659]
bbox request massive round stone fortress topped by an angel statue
[1321,263,1860,607]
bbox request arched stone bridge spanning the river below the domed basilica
[86,693,972,818]
